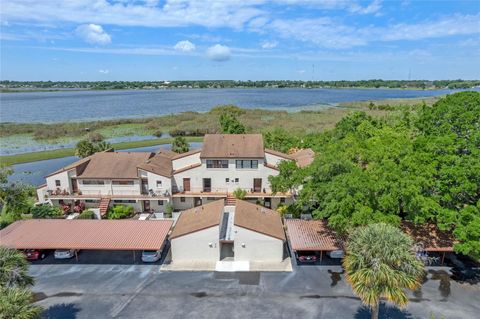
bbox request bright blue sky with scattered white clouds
[0,0,480,81]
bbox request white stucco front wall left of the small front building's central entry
[171,226,220,263]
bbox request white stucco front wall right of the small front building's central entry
[234,226,283,262]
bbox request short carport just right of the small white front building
[285,219,346,262]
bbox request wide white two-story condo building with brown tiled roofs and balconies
[37,134,313,214]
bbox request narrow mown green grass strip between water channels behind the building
[0,136,203,166]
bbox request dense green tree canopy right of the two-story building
[271,92,480,257]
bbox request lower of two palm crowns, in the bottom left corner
[0,288,42,319]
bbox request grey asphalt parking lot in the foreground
[31,252,480,319]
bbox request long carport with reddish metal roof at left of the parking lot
[0,219,173,260]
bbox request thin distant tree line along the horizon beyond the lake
[0,79,480,91]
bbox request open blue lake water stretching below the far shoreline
[0,88,455,123]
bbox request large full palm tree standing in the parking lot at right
[343,223,423,319]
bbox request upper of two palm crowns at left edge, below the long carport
[0,247,33,289]
